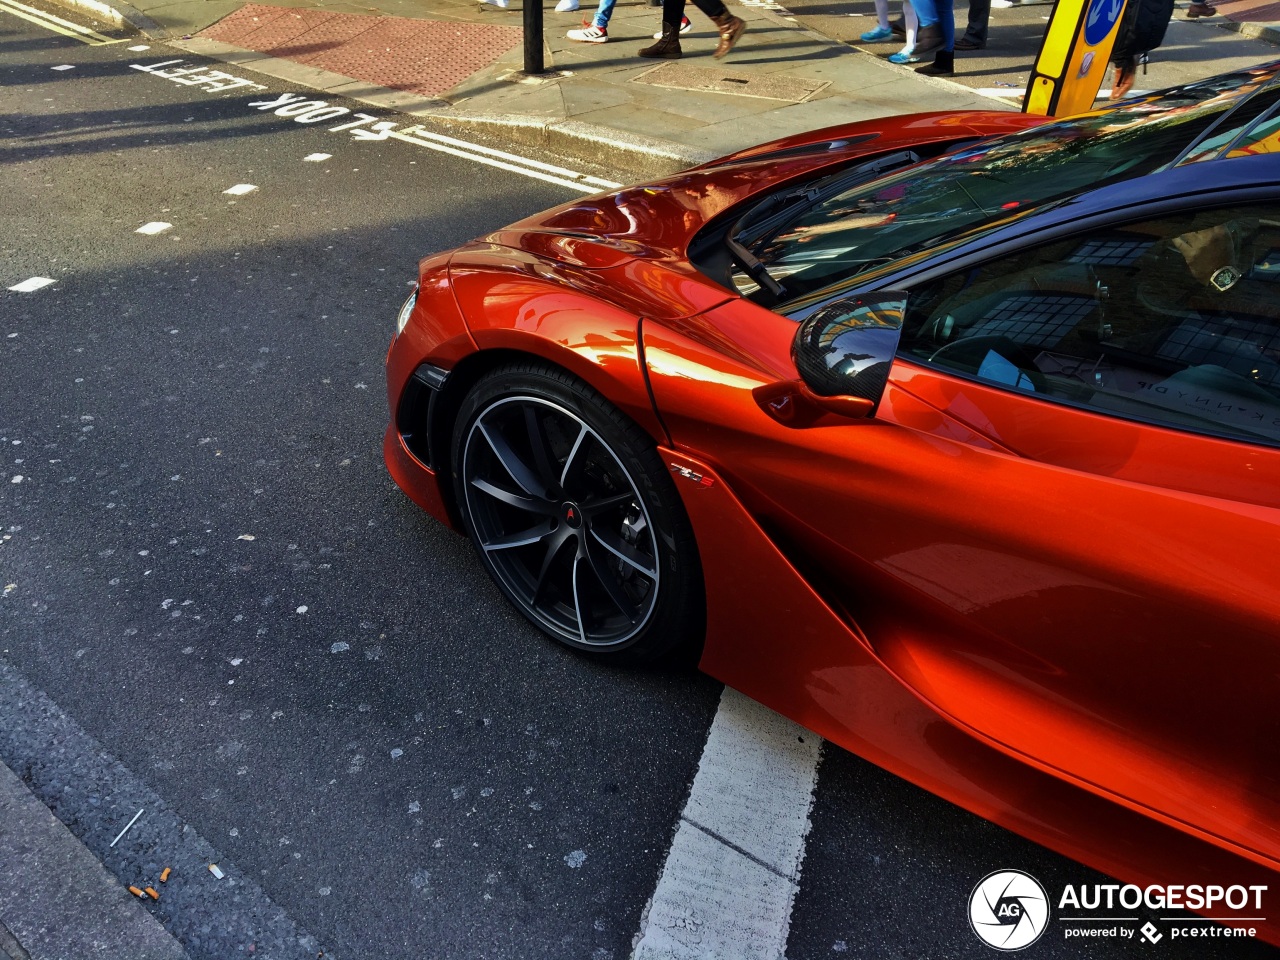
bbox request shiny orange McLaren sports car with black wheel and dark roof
[384,61,1280,942]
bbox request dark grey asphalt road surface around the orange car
[0,9,1275,960]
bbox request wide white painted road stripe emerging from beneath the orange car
[632,687,822,960]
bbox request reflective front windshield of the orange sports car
[727,61,1280,306]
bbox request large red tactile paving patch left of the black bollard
[200,4,524,96]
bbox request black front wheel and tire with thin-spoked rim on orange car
[451,362,705,662]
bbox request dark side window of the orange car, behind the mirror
[899,204,1280,443]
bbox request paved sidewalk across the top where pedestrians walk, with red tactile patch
[49,0,1280,177]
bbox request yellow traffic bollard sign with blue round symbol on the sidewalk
[1023,0,1125,116]
